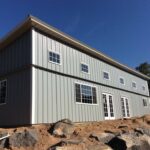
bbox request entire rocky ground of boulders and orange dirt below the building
[0,115,150,150]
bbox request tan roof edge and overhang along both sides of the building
[0,14,150,80]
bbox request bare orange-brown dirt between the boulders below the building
[0,115,150,150]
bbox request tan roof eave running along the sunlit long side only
[31,17,150,80]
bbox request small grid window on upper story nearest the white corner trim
[49,51,60,64]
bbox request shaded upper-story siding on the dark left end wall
[0,31,32,76]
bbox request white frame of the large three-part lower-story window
[74,82,99,106]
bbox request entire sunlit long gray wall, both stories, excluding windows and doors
[32,30,150,123]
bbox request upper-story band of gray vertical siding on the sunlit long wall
[33,31,149,96]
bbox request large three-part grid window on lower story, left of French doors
[75,83,97,104]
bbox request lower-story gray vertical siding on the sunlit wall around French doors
[35,69,150,123]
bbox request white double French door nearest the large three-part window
[102,93,115,120]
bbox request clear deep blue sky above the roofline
[0,0,150,68]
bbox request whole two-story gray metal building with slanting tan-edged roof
[0,16,150,126]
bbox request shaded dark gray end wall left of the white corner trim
[0,31,32,126]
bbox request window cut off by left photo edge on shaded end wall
[0,80,7,104]
